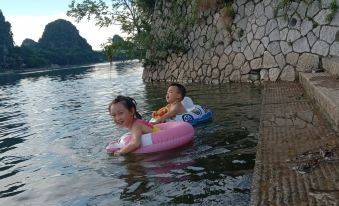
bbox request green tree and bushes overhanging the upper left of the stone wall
[67,0,234,66]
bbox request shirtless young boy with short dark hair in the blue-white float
[152,83,186,124]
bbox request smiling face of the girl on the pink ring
[110,102,134,128]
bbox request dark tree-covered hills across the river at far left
[0,10,105,71]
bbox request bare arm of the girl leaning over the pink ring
[114,124,142,155]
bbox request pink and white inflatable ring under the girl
[106,122,194,154]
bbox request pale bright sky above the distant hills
[0,0,126,50]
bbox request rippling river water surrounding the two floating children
[0,62,261,206]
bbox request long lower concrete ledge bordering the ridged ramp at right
[299,72,339,131]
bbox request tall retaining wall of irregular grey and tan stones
[143,0,339,84]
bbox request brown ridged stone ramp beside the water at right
[250,83,339,206]
